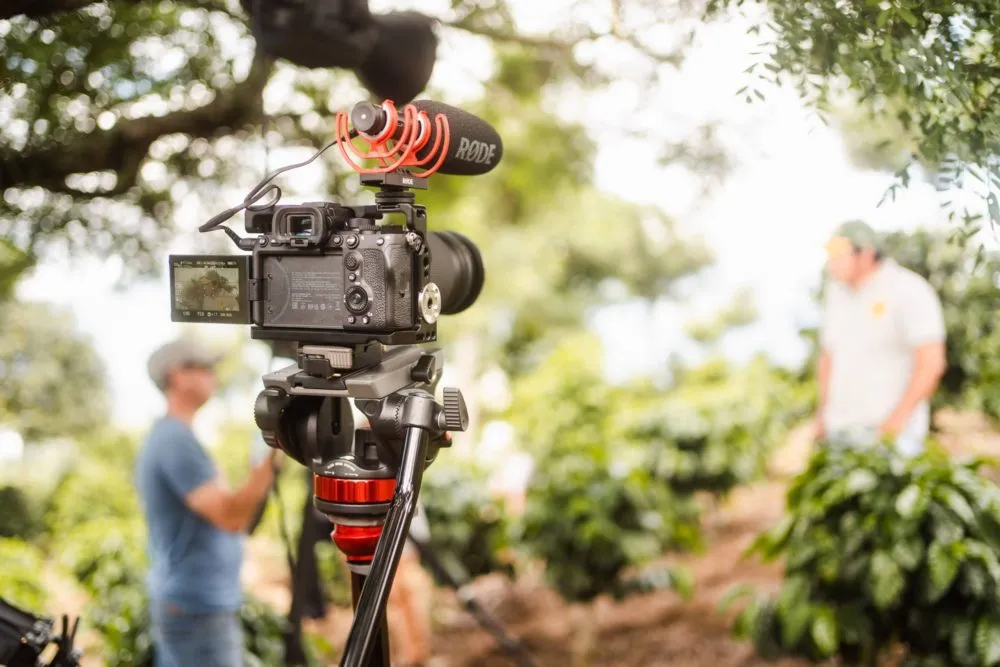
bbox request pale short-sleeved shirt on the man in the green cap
[820,260,945,442]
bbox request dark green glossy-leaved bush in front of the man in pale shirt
[736,447,1000,666]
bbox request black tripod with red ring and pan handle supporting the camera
[254,343,469,667]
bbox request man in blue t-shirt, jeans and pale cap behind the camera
[135,339,278,667]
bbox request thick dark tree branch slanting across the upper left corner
[0,55,272,196]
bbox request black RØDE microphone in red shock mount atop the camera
[350,100,503,176]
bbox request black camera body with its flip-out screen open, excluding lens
[170,194,441,345]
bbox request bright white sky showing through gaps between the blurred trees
[11,0,988,448]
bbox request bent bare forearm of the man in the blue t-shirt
[184,450,279,533]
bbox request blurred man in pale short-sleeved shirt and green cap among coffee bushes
[817,221,946,455]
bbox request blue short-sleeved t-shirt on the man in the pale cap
[135,417,243,612]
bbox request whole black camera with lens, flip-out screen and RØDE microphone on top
[170,102,503,354]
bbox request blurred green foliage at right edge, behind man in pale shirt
[885,230,1000,419]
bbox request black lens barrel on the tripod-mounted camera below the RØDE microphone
[427,232,486,315]
